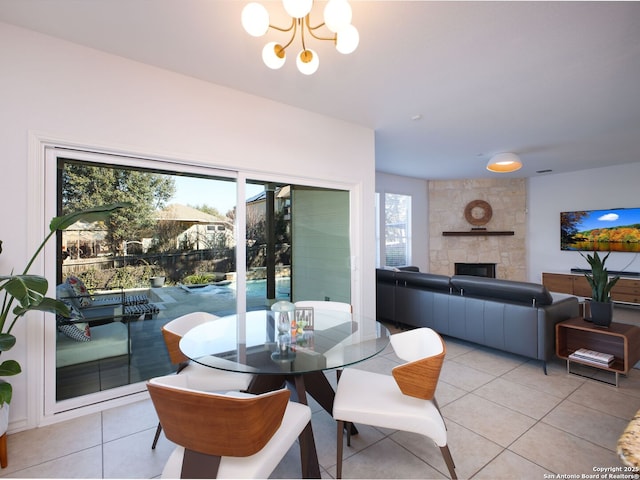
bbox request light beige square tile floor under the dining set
[0,316,640,479]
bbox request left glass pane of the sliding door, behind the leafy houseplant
[56,157,236,401]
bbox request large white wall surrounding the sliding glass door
[0,23,375,428]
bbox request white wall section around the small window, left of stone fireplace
[376,172,429,272]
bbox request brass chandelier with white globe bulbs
[242,0,360,75]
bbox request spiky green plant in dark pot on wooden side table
[580,252,620,327]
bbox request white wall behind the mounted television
[528,163,640,282]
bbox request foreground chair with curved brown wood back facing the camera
[147,374,311,478]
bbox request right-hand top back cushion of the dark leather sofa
[451,275,553,306]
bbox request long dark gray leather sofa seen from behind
[376,268,579,373]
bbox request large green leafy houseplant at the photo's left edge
[0,203,130,407]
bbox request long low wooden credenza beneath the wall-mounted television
[542,272,640,305]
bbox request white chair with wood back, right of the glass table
[333,328,457,479]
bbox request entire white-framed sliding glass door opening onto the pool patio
[46,149,351,411]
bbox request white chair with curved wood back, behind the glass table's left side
[151,312,253,449]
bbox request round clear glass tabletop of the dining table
[180,309,389,375]
